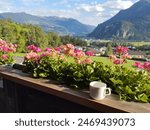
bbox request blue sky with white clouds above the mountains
[0,0,139,26]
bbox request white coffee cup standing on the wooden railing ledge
[90,81,111,100]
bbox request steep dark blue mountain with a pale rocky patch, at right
[88,0,150,41]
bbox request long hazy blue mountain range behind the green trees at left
[0,12,94,36]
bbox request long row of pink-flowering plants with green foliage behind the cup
[23,44,150,102]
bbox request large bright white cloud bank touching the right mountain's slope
[76,0,135,25]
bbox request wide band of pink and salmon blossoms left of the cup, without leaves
[25,44,93,64]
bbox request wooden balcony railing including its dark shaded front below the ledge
[0,69,150,113]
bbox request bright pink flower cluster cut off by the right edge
[133,62,150,73]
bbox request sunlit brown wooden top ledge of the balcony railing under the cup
[0,68,150,113]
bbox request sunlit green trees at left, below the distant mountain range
[0,19,86,52]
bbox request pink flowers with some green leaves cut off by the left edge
[0,39,17,65]
